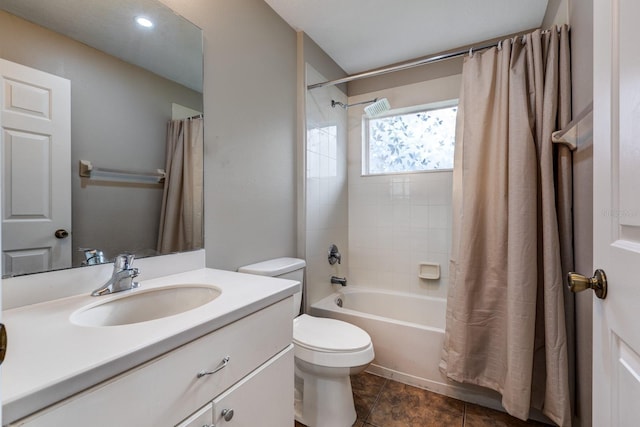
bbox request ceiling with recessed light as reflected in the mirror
[0,0,202,92]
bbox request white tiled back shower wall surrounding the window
[348,75,460,298]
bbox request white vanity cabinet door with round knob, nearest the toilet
[213,345,294,427]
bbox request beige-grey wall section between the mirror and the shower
[162,0,297,270]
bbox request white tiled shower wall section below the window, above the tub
[349,171,452,297]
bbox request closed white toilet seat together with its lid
[293,314,374,368]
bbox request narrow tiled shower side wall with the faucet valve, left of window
[305,64,348,310]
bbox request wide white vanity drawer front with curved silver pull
[14,297,293,427]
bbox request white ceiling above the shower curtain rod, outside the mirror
[265,0,548,74]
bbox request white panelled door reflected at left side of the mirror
[0,59,71,276]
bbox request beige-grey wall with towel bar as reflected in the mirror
[0,11,202,265]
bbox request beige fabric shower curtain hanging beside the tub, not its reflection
[441,26,573,426]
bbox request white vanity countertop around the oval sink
[2,268,300,425]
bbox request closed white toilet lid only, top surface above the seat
[293,314,371,352]
